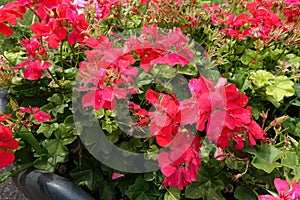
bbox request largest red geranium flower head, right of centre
[188,76,266,150]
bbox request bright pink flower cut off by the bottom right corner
[258,178,300,200]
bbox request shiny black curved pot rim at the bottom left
[13,169,94,200]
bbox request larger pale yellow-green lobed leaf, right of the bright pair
[266,76,295,101]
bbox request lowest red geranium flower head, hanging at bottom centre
[158,132,201,190]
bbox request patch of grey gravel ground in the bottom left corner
[0,169,27,200]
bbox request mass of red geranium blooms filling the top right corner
[203,0,299,43]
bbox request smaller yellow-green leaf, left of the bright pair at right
[249,70,275,88]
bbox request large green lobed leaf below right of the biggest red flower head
[245,143,282,173]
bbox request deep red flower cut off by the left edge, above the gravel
[0,124,19,168]
